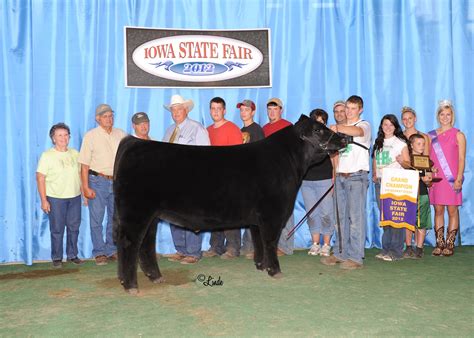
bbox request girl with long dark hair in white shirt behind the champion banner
[372,114,410,261]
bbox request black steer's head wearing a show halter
[295,115,346,155]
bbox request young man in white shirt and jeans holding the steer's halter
[321,95,371,270]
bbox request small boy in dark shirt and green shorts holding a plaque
[405,134,433,259]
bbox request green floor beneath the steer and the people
[0,247,474,337]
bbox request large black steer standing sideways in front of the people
[114,115,344,293]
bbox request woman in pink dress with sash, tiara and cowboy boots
[428,100,466,256]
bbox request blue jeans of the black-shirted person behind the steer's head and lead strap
[301,179,334,236]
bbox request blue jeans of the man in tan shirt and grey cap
[89,175,117,257]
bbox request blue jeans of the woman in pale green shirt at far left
[47,195,81,261]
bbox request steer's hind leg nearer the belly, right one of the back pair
[138,219,164,283]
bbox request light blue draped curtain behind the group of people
[0,0,474,264]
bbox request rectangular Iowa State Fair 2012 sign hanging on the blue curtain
[124,27,271,88]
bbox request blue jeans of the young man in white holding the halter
[334,172,369,264]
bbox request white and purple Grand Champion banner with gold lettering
[380,168,420,231]
